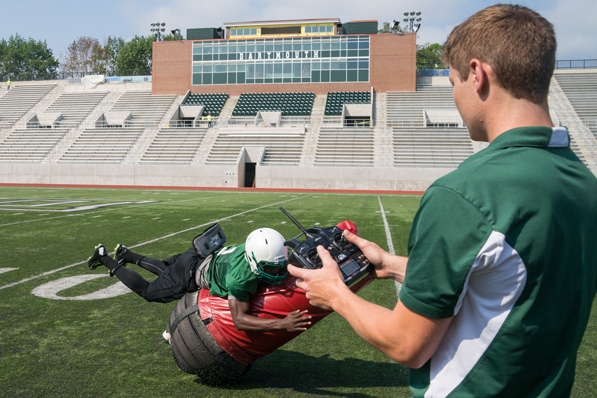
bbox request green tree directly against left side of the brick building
[115,36,155,76]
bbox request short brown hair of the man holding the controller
[443,4,556,103]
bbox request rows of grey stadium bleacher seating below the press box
[0,71,597,186]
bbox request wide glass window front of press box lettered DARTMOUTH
[192,36,370,85]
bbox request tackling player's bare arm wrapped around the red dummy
[228,297,311,332]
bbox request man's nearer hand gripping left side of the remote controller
[288,246,353,310]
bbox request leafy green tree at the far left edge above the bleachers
[0,34,59,80]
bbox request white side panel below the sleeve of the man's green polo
[425,231,527,397]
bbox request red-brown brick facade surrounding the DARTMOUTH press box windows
[152,33,416,96]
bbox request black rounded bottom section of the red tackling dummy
[168,292,252,384]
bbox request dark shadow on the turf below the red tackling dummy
[195,350,408,398]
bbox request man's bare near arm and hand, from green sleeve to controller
[288,246,452,368]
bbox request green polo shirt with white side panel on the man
[400,127,597,397]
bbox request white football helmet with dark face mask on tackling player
[245,228,288,284]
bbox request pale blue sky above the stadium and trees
[0,0,597,60]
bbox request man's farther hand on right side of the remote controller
[344,231,408,282]
